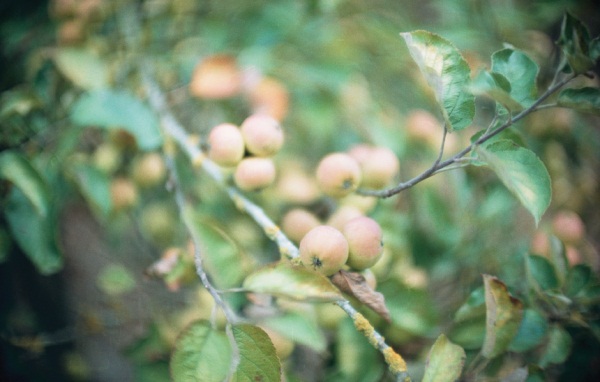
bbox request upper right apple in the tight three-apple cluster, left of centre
[240,114,283,157]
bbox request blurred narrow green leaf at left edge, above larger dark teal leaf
[0,151,50,217]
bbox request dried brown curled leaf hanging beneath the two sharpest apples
[331,270,392,322]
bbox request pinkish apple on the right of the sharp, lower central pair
[343,216,383,271]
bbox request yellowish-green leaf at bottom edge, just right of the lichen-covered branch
[423,334,466,382]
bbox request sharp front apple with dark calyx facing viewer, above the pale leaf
[300,225,348,276]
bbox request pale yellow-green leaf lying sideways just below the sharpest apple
[243,260,342,302]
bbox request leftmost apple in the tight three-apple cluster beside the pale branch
[208,123,245,167]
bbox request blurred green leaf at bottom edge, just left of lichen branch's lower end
[335,318,385,382]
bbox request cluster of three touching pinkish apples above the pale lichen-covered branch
[208,114,284,191]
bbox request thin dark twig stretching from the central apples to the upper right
[356,74,576,198]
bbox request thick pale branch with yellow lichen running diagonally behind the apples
[141,67,412,382]
